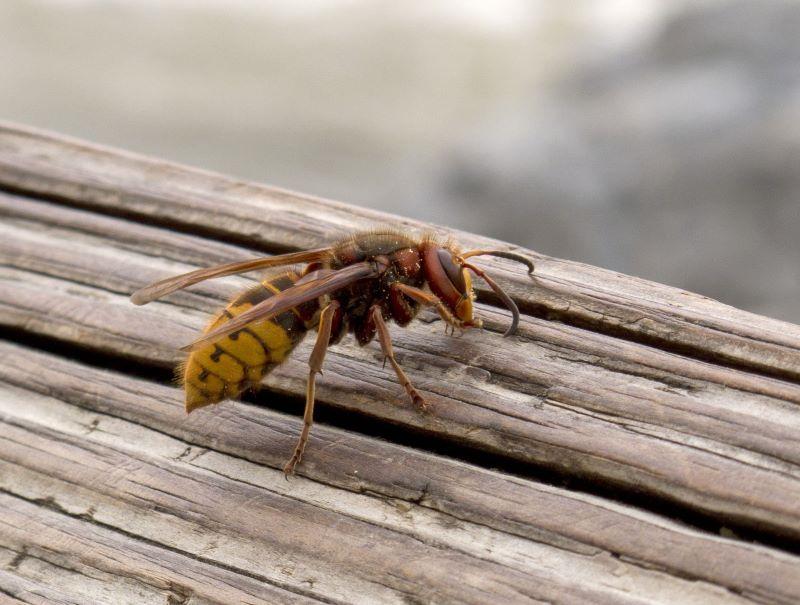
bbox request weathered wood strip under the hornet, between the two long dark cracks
[0,196,800,537]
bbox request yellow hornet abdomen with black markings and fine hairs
[180,272,308,412]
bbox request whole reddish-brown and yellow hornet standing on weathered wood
[131,230,534,477]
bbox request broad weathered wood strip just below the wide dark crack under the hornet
[0,344,800,603]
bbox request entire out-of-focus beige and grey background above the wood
[0,0,800,322]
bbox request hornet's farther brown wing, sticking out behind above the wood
[131,248,333,305]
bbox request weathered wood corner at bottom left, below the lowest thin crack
[0,496,316,605]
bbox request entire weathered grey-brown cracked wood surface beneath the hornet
[0,120,800,603]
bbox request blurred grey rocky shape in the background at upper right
[438,0,800,322]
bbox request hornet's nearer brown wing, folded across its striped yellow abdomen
[182,263,381,351]
